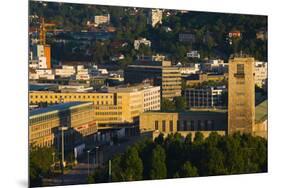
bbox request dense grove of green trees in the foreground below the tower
[88,132,267,183]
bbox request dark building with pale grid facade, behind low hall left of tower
[183,87,226,108]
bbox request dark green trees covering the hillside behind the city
[30,1,267,64]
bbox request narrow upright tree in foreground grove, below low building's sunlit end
[150,145,167,179]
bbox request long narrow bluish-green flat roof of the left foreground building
[29,102,92,117]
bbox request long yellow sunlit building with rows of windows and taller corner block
[29,85,160,125]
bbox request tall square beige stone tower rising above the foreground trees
[228,57,255,134]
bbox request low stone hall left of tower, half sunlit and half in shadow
[140,110,227,139]
